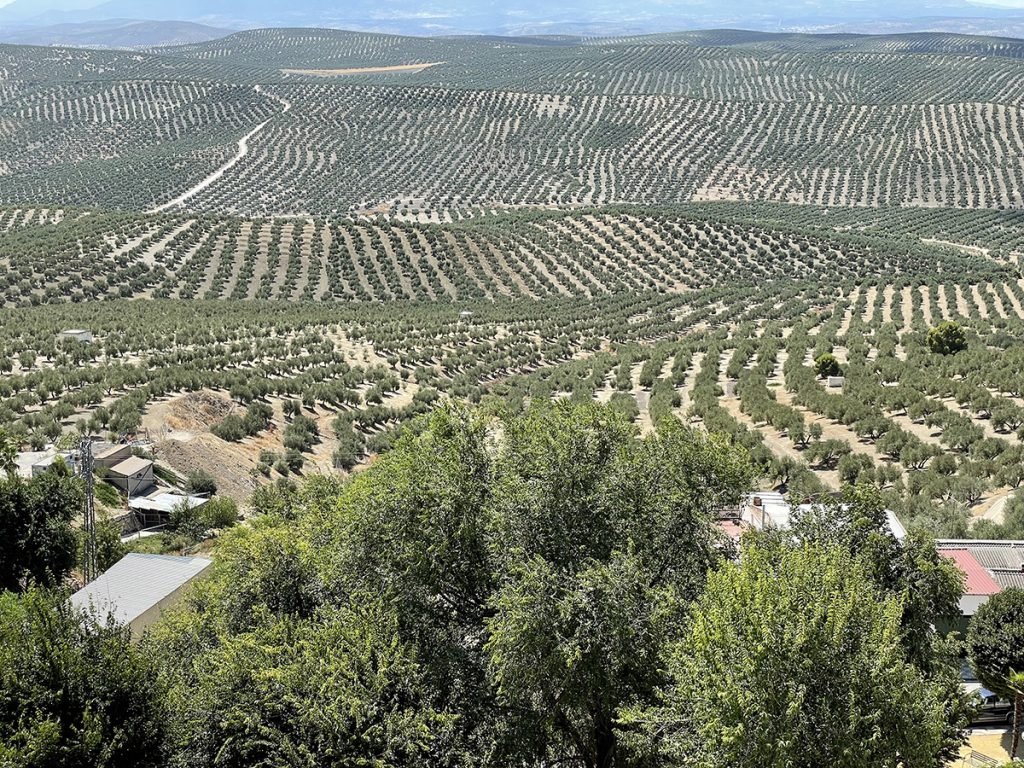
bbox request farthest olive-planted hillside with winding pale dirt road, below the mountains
[6,30,1024,214]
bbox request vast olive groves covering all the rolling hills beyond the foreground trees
[0,30,1024,536]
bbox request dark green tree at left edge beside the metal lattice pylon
[0,466,83,591]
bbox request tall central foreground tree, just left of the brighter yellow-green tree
[486,407,751,768]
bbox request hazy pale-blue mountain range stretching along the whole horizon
[0,0,1024,36]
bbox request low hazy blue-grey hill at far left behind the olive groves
[0,19,232,48]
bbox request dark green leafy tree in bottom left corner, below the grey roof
[0,590,166,768]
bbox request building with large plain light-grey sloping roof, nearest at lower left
[71,553,213,638]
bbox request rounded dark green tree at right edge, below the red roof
[967,589,1024,758]
